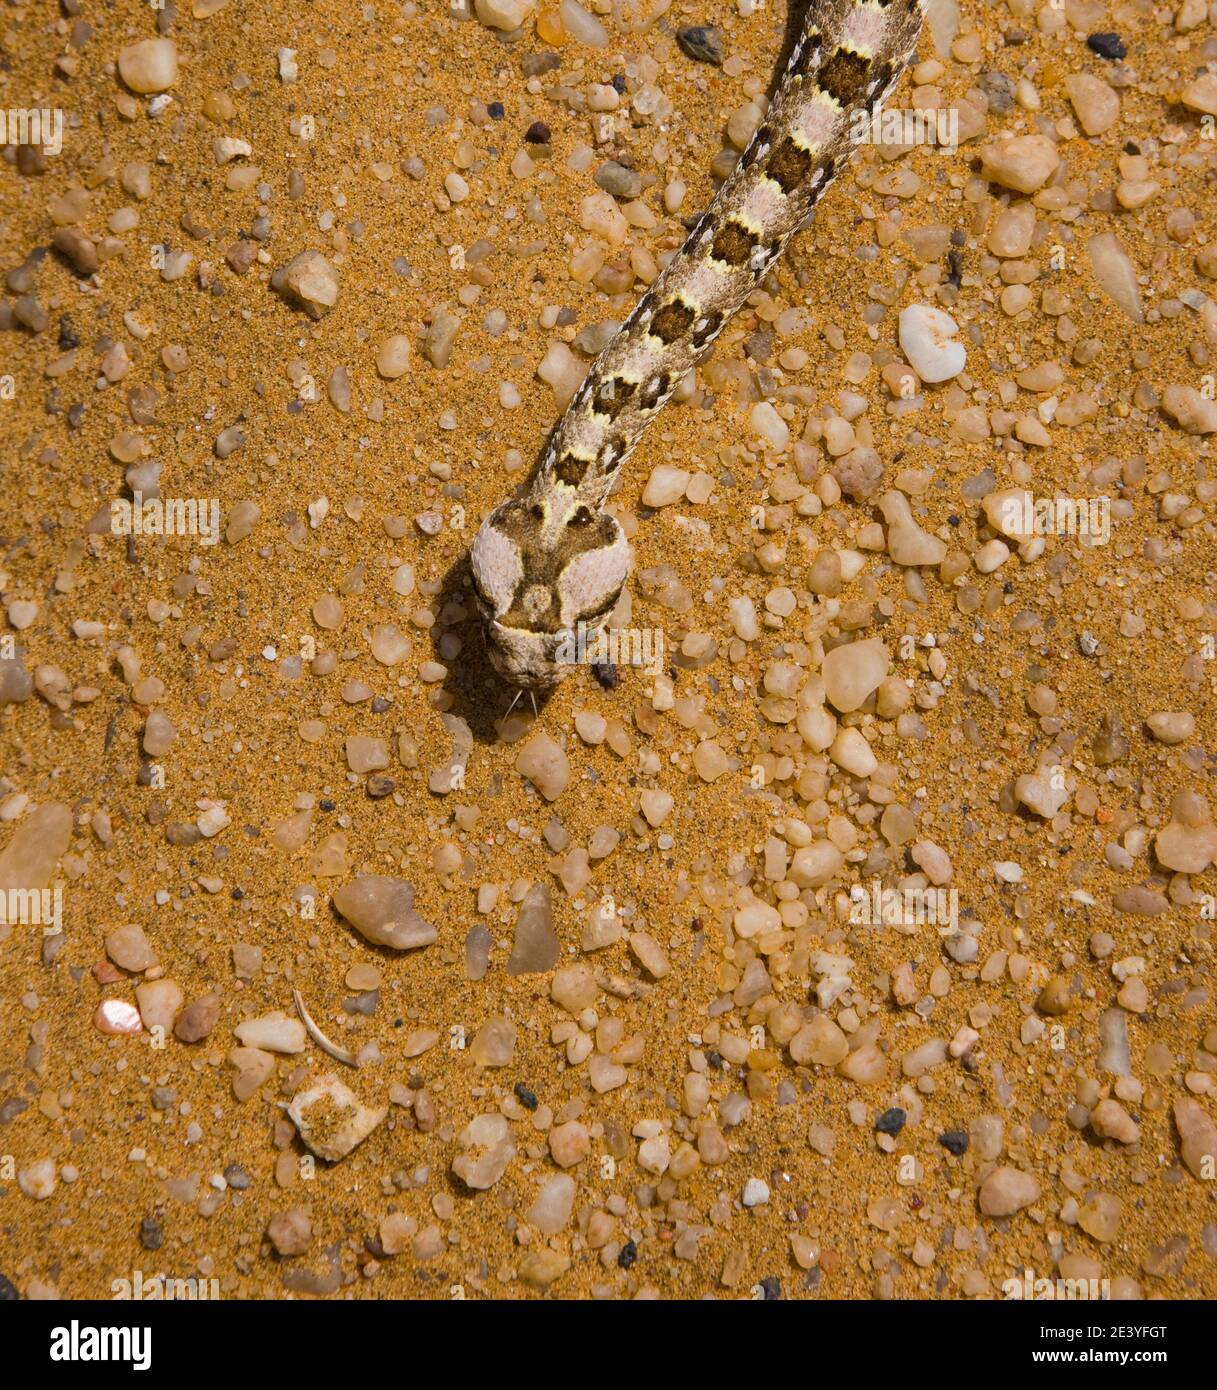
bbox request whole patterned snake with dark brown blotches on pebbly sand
[470,0,924,692]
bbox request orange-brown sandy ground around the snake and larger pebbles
[0,0,1217,1298]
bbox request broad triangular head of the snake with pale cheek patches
[470,498,629,689]
